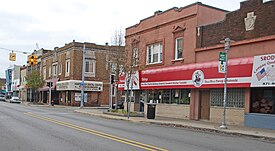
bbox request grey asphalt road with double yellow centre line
[0,102,275,151]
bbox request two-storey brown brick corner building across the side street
[40,41,124,106]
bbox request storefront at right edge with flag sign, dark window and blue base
[245,54,275,129]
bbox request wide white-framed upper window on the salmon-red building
[146,43,162,64]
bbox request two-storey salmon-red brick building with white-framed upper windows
[119,2,227,119]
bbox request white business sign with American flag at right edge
[251,54,275,87]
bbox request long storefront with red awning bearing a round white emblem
[119,57,253,124]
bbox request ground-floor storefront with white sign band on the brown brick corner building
[56,80,103,106]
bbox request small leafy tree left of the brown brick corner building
[26,70,45,102]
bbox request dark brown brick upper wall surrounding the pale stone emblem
[197,0,275,48]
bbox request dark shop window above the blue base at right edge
[251,88,275,114]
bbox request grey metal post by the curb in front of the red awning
[220,38,231,129]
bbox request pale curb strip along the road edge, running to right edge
[74,110,275,142]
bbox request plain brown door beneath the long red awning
[200,90,210,120]
